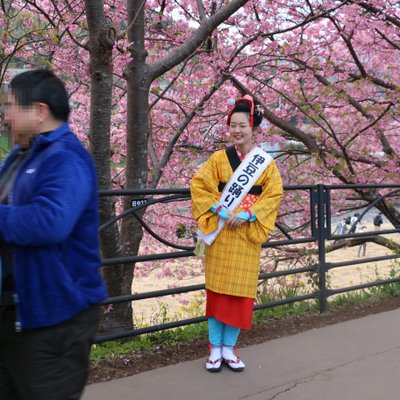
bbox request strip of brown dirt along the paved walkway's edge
[88,297,400,384]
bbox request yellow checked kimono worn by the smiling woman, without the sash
[190,150,283,298]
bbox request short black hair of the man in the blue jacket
[10,69,70,122]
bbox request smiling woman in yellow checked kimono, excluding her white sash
[190,96,283,372]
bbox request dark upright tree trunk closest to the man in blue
[85,0,132,332]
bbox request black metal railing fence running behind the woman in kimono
[96,185,400,343]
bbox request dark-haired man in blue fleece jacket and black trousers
[0,69,107,400]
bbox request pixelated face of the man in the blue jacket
[4,93,40,148]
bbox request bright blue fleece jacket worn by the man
[0,123,107,328]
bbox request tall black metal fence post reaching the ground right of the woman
[317,185,327,313]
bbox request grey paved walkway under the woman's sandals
[83,310,400,400]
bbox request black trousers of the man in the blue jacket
[0,305,100,400]
